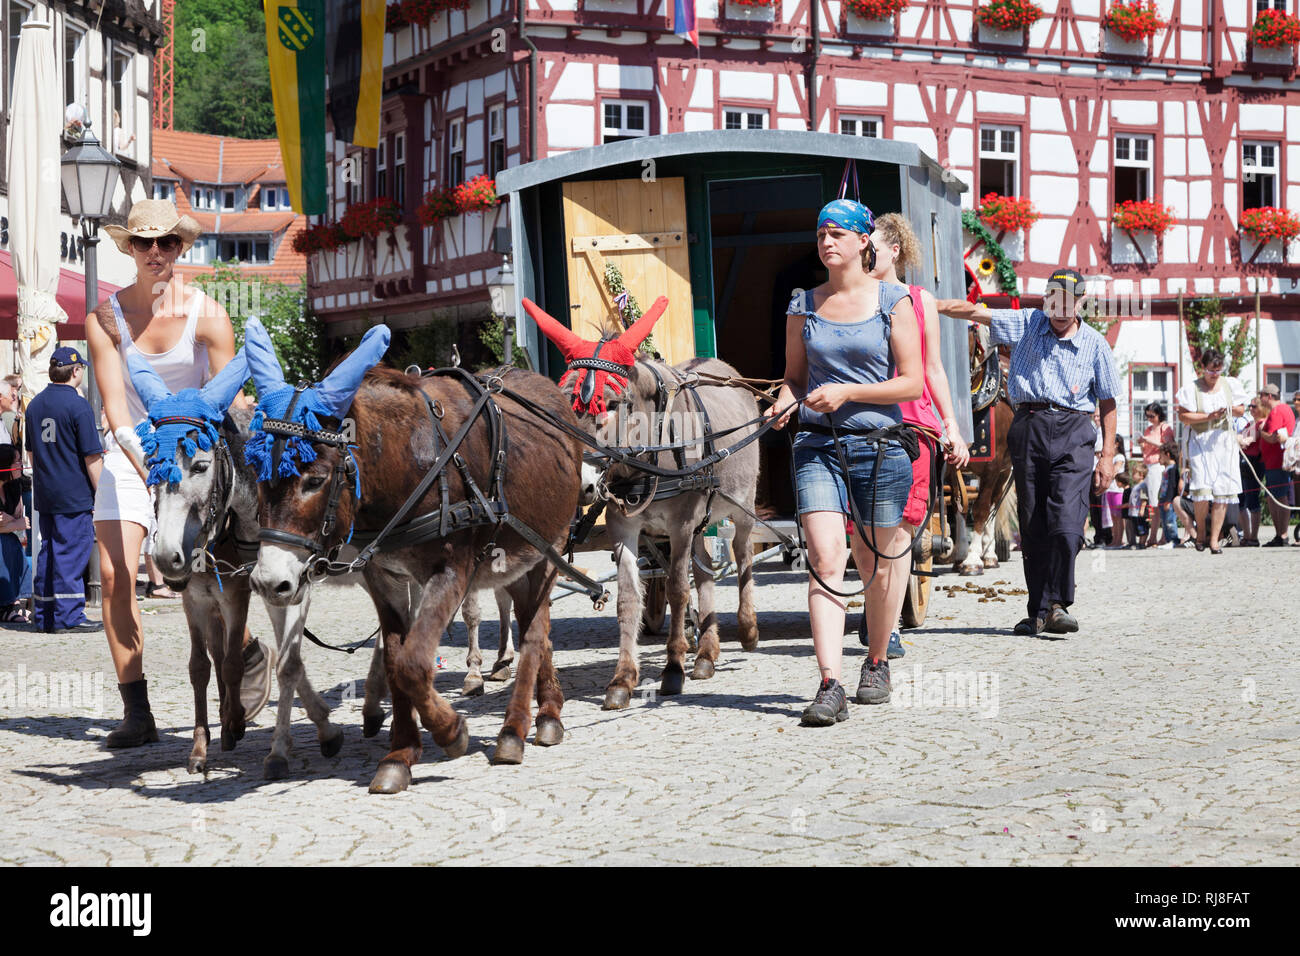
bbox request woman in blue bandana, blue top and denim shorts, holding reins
[768,199,924,727]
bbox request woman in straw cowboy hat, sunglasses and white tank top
[86,199,272,747]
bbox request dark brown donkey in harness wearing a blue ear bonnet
[244,320,582,793]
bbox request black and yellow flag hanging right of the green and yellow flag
[326,0,387,150]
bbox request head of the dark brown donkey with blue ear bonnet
[244,319,391,605]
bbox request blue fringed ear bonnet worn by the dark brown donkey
[244,319,393,481]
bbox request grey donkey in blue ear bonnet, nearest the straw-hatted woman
[127,350,343,779]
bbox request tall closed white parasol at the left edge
[8,20,68,398]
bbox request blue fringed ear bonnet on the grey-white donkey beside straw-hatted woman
[126,349,248,486]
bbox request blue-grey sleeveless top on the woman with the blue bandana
[788,282,910,446]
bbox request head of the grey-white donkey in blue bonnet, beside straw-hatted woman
[126,349,248,589]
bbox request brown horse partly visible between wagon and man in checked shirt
[958,326,1015,575]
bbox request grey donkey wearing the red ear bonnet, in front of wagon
[524,297,759,710]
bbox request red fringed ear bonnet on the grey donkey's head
[524,295,668,419]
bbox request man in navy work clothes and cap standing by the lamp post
[26,347,104,633]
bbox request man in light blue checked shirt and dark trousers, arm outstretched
[939,268,1119,635]
